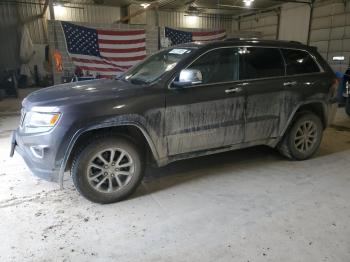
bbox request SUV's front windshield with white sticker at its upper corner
[123,48,193,84]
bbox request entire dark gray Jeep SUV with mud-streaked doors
[11,40,336,203]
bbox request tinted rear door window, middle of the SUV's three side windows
[239,47,285,79]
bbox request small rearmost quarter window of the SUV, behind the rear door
[281,49,320,75]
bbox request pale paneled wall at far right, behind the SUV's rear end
[310,0,350,71]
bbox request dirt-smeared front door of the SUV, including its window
[165,47,245,156]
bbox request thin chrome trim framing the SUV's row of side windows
[168,45,325,89]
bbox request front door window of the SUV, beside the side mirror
[188,48,239,84]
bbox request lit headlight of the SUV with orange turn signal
[23,112,61,133]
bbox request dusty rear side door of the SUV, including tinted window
[239,47,285,142]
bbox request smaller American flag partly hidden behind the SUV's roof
[165,27,226,45]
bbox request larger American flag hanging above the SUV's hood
[61,22,146,77]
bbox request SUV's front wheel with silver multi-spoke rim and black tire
[71,136,144,204]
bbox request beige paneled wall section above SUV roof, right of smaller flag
[240,11,278,39]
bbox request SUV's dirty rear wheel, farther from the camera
[277,113,323,160]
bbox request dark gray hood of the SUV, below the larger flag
[23,79,143,108]
